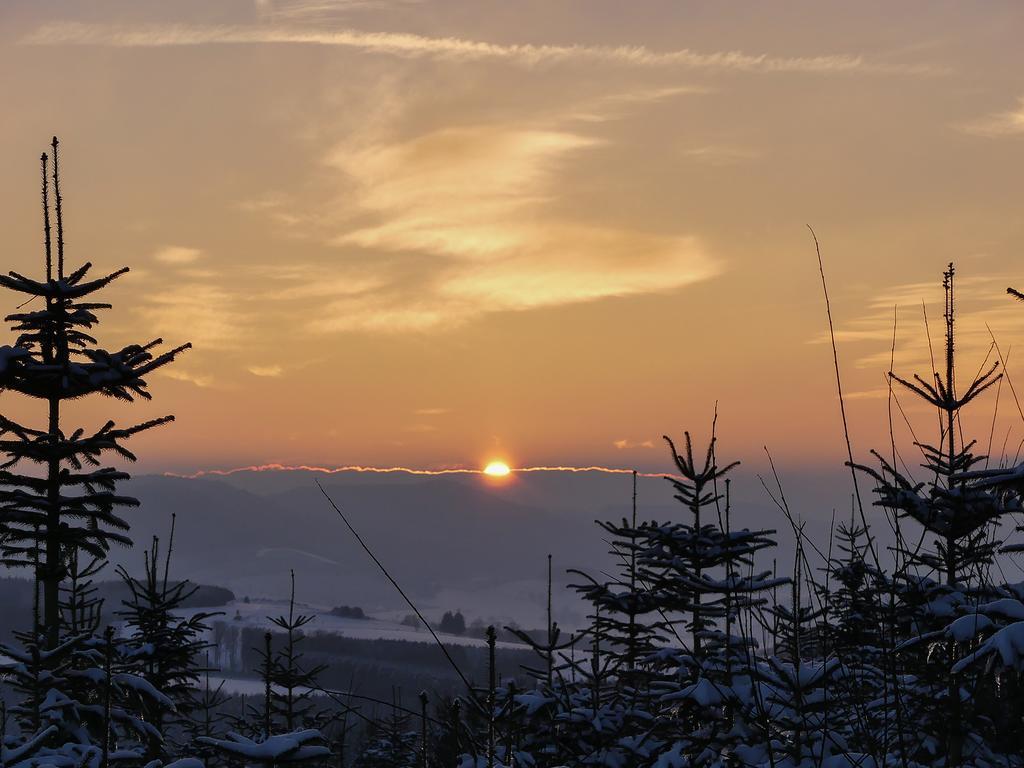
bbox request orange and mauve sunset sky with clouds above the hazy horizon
[0,0,1024,472]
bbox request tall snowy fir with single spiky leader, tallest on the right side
[855,264,1021,766]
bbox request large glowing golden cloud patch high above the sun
[312,118,721,331]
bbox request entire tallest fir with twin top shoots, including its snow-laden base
[0,138,188,765]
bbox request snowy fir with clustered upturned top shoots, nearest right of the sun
[640,426,785,762]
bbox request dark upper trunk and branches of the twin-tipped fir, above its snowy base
[0,137,189,649]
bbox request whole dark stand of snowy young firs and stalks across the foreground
[0,138,1024,768]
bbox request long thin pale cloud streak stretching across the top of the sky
[23,22,933,74]
